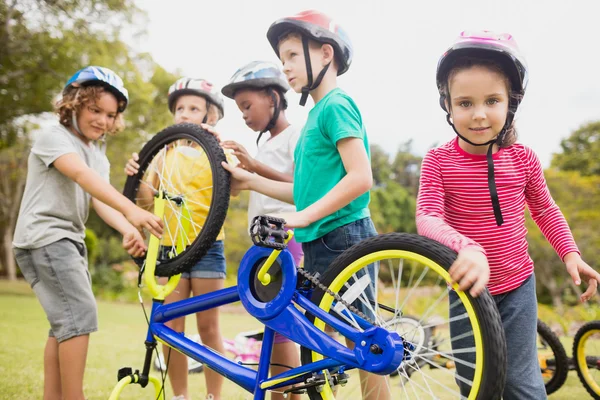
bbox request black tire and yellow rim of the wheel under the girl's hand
[301,233,506,400]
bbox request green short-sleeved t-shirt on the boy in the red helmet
[294,88,370,242]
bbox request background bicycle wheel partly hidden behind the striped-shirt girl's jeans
[537,319,569,394]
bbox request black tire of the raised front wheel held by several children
[123,123,231,277]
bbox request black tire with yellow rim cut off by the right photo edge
[573,321,600,399]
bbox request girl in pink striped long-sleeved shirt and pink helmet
[417,32,600,400]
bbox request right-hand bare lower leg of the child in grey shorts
[58,335,90,400]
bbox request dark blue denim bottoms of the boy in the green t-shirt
[302,217,379,318]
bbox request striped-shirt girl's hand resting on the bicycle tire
[448,248,490,297]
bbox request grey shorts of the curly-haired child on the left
[14,239,98,342]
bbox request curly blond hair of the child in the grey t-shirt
[54,86,125,135]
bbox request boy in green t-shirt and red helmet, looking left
[223,11,387,399]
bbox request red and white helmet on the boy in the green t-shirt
[267,10,354,106]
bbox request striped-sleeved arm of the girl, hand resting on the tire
[417,151,490,297]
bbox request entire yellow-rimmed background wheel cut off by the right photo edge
[573,321,600,399]
